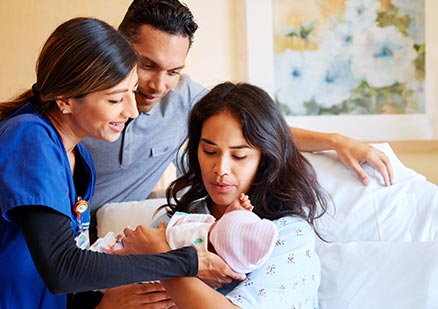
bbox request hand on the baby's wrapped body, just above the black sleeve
[114,222,170,254]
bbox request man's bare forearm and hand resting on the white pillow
[290,127,393,186]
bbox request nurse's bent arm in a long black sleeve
[11,206,198,294]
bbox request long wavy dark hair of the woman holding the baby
[166,82,327,236]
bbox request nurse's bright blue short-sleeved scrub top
[0,103,95,309]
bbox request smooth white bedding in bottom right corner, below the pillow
[317,242,438,309]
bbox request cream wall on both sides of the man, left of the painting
[0,0,239,100]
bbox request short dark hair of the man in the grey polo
[119,0,198,46]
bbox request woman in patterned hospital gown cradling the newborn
[130,82,326,309]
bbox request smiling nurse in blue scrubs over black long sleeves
[0,18,198,308]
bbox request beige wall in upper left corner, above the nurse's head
[0,0,131,100]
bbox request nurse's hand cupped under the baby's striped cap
[198,252,246,288]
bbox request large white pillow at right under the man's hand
[305,143,438,242]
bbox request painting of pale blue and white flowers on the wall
[272,0,425,115]
